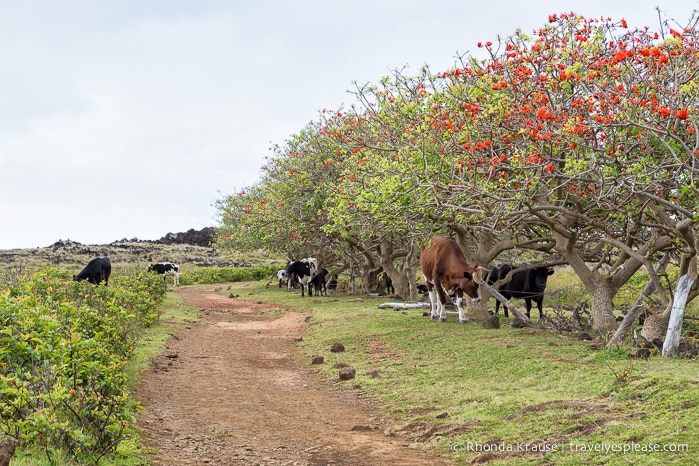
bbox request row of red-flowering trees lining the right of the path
[218,13,699,330]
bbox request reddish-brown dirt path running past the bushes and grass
[138,286,446,466]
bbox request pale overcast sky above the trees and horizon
[0,0,699,249]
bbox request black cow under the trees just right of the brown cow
[488,264,553,319]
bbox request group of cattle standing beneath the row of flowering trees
[277,236,554,323]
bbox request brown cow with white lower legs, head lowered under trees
[420,236,487,324]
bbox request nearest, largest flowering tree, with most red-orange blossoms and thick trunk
[424,14,699,330]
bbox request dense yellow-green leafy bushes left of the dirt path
[0,269,165,464]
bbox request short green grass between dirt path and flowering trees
[220,282,699,465]
